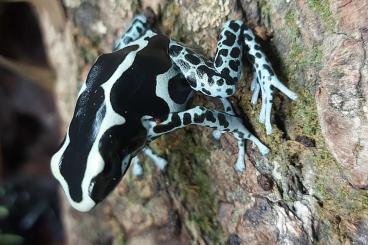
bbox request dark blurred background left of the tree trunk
[0,1,64,245]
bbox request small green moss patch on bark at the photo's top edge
[307,0,336,31]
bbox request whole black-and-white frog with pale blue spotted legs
[51,15,296,211]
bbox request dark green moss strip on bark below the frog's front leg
[163,132,222,244]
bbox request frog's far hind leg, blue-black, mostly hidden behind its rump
[113,15,151,51]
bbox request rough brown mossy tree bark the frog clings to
[45,0,368,244]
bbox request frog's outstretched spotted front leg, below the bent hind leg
[142,106,269,171]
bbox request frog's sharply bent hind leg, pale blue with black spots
[169,20,297,134]
